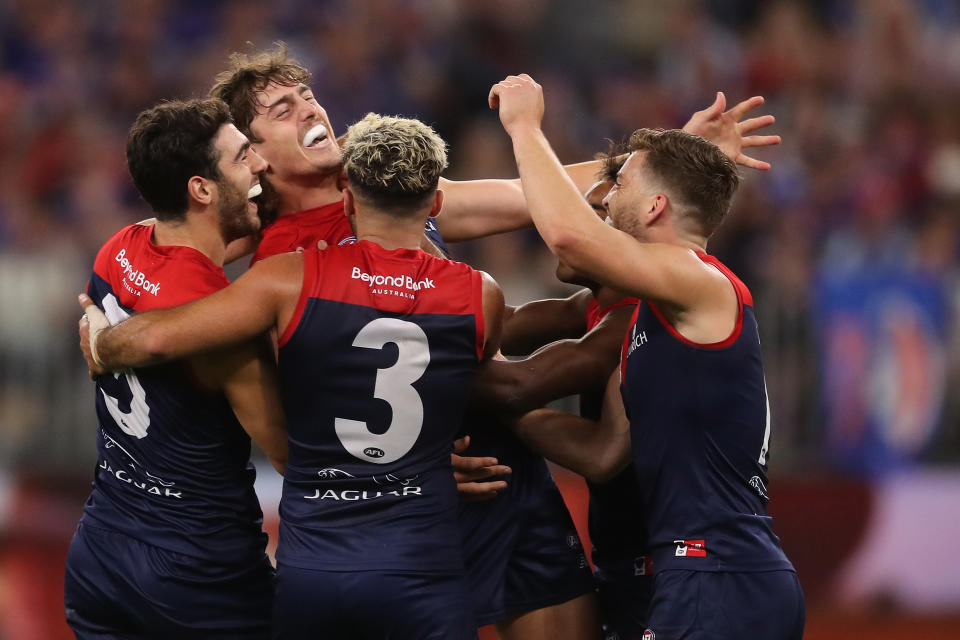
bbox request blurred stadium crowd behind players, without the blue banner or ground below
[0,0,960,484]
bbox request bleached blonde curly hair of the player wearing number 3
[341,113,447,210]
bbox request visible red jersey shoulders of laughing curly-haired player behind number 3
[250,200,450,266]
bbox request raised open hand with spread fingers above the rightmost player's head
[683,91,780,171]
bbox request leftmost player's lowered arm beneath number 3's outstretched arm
[190,336,287,474]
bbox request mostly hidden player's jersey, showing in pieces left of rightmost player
[580,298,649,575]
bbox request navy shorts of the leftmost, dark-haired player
[63,523,274,640]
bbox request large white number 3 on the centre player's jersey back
[335,318,430,464]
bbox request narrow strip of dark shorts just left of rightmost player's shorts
[593,556,653,640]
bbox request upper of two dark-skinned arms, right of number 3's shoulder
[500,289,593,356]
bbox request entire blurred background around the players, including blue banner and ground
[0,0,960,638]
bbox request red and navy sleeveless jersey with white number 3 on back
[277,241,484,571]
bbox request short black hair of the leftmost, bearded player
[127,98,232,220]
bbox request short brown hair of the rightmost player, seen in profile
[629,129,740,237]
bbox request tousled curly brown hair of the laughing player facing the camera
[210,41,310,142]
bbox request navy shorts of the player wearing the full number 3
[273,564,477,640]
